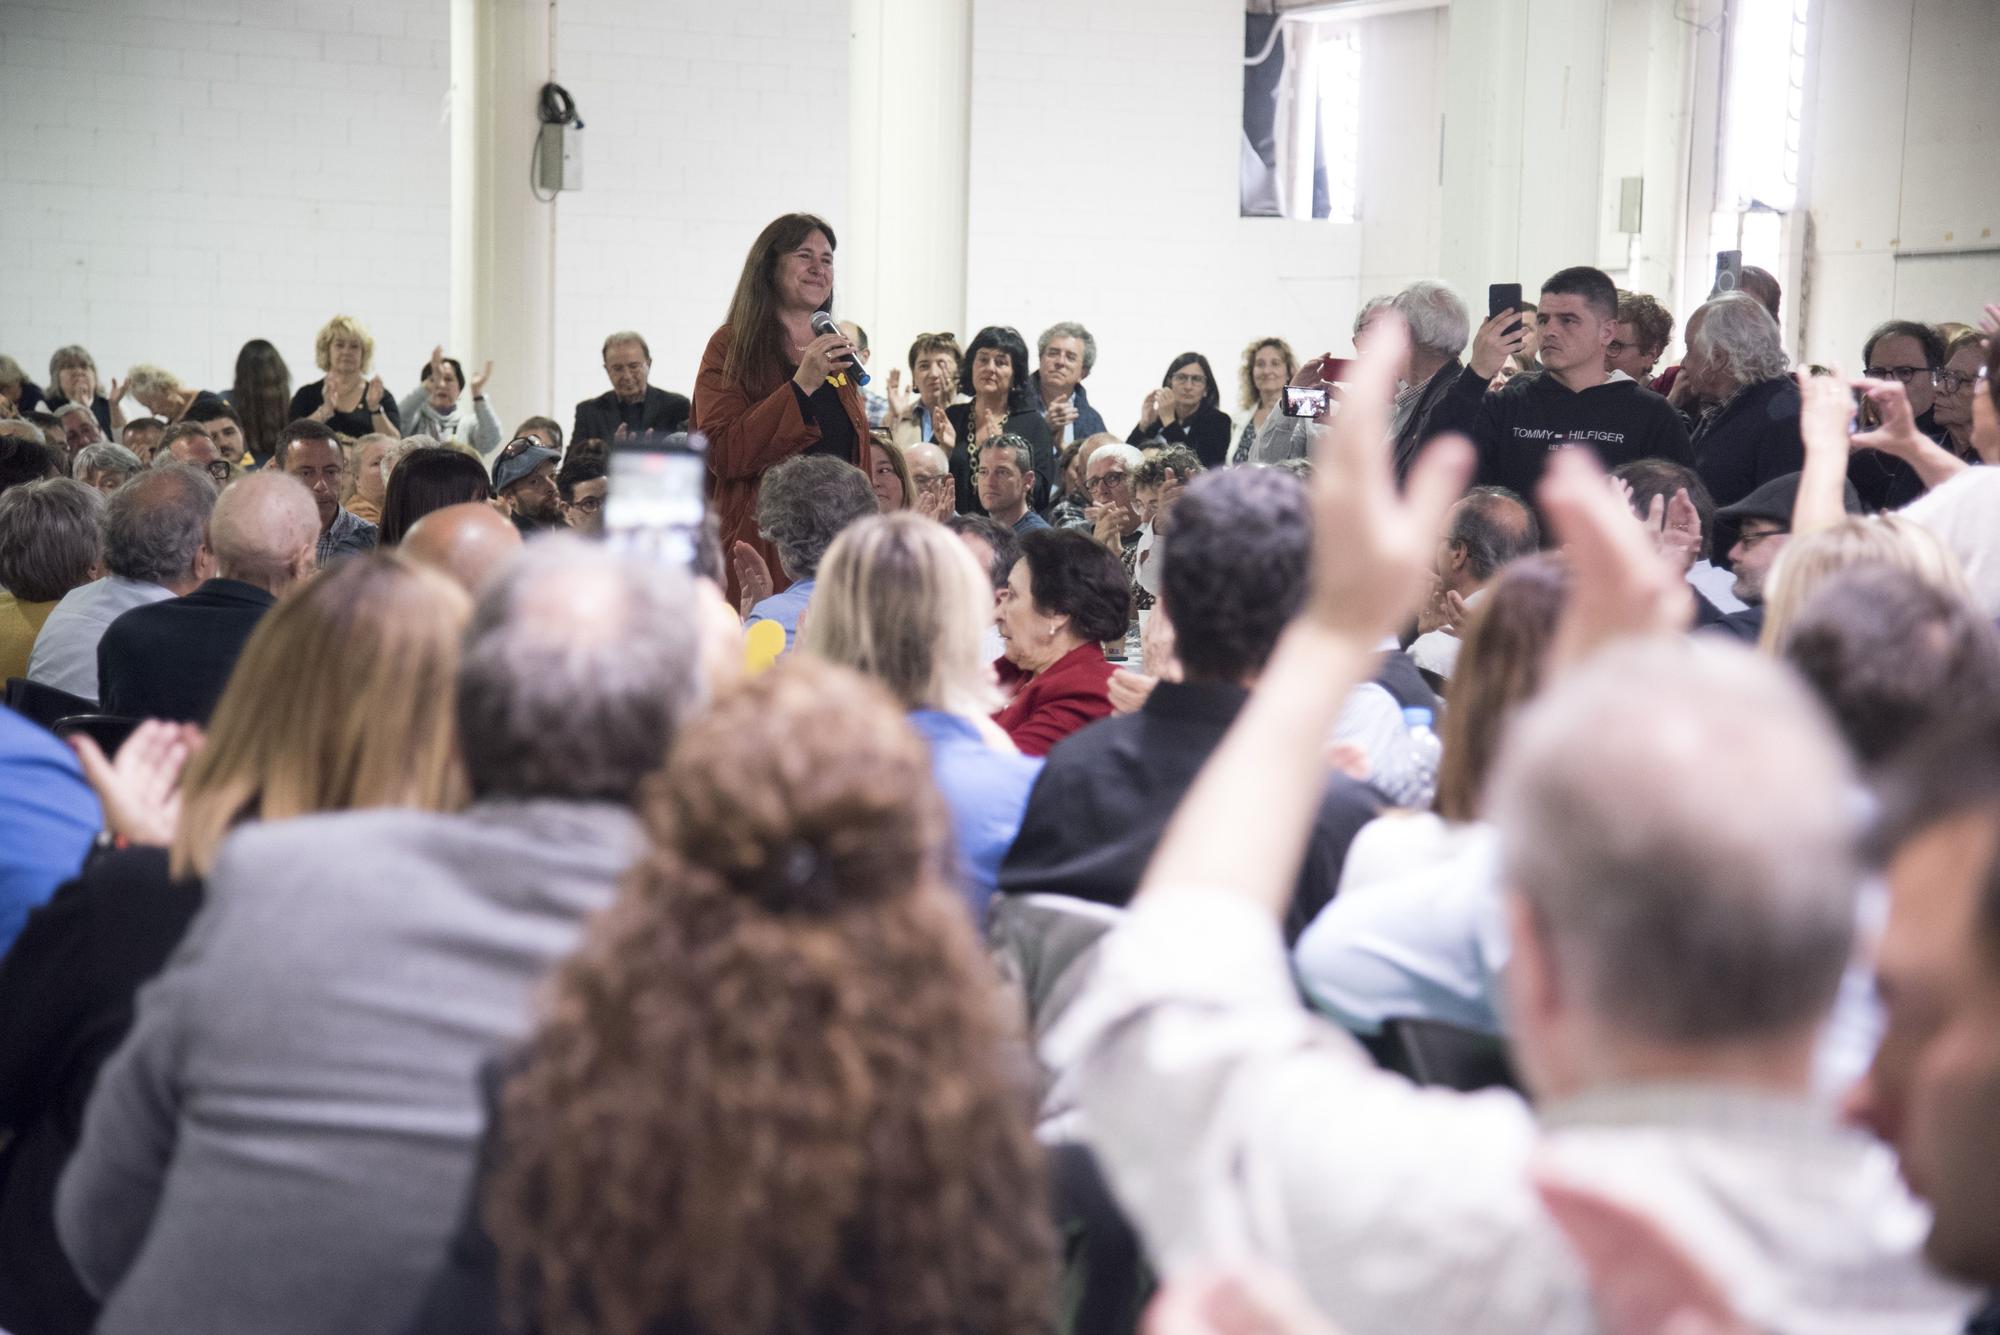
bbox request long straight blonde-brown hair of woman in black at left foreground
[172,554,472,877]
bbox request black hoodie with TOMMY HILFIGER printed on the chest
[1428,366,1692,502]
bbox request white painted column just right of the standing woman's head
[832,0,972,388]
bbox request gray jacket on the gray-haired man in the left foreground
[56,801,644,1335]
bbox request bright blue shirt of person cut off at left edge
[0,709,104,953]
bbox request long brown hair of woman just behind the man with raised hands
[1436,552,1570,821]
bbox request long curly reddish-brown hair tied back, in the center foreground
[484,658,1056,1335]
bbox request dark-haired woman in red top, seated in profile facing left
[994,530,1132,755]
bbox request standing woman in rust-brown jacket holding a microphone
[692,214,868,602]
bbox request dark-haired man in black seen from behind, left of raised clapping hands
[996,468,1380,937]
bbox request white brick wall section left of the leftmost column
[0,0,450,411]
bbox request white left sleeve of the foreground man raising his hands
[1044,887,1536,1329]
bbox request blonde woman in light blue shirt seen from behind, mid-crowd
[800,514,1042,917]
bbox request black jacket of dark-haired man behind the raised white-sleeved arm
[1000,681,1380,939]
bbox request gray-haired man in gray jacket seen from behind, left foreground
[56,536,700,1335]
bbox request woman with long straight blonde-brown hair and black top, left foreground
[0,556,470,1329]
